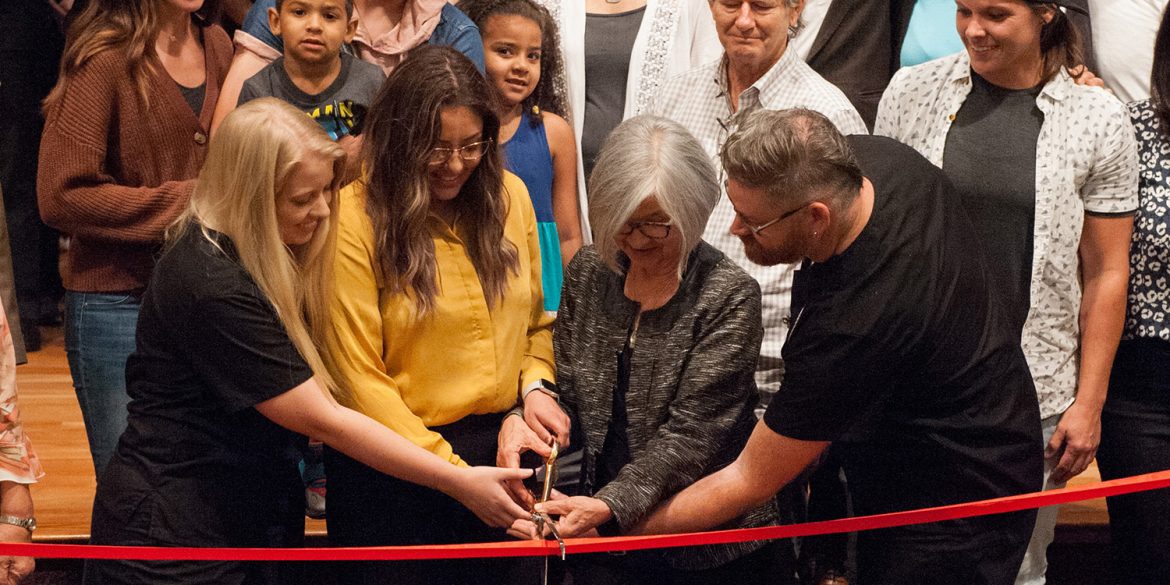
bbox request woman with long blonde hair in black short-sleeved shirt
[85,98,527,585]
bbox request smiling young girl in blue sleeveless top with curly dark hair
[460,0,581,311]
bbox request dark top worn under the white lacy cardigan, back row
[581,6,646,179]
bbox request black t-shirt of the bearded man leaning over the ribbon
[764,136,1041,515]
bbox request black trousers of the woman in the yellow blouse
[325,414,516,585]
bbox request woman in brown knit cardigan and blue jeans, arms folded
[37,0,232,475]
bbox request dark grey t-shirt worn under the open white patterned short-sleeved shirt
[943,71,1044,333]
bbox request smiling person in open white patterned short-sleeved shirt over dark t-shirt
[874,0,1137,584]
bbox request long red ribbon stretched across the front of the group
[11,470,1170,560]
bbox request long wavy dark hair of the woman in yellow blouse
[362,44,519,316]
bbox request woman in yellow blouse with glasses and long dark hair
[325,47,569,583]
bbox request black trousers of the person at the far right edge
[1097,338,1170,585]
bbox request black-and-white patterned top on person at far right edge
[1123,99,1170,342]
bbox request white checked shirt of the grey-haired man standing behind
[651,50,868,407]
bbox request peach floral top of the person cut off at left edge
[0,308,44,483]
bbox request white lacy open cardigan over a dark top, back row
[537,0,723,243]
